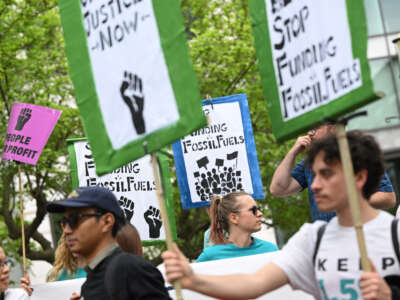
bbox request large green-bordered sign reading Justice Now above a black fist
[59,0,206,175]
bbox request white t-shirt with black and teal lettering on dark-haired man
[273,211,400,300]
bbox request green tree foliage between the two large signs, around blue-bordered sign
[161,0,310,259]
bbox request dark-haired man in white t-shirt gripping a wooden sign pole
[162,132,400,300]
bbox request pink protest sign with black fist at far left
[2,103,61,165]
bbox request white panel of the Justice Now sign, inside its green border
[81,0,179,149]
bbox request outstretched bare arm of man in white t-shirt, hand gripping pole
[162,245,289,299]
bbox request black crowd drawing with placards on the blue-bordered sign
[193,151,243,201]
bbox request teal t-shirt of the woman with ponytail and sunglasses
[196,237,279,262]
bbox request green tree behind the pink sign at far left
[0,0,82,262]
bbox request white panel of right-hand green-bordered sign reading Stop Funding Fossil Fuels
[265,0,362,121]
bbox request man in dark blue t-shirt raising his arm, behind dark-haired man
[269,122,396,222]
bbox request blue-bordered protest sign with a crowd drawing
[172,94,264,209]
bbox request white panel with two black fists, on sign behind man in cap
[74,141,165,241]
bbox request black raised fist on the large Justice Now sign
[120,71,146,134]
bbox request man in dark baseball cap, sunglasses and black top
[47,187,170,300]
